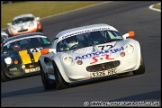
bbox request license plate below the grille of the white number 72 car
[90,68,117,78]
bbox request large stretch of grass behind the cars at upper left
[1,1,104,28]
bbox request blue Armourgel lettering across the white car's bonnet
[75,47,124,60]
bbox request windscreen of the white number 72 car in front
[57,30,123,52]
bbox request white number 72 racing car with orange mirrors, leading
[39,24,145,90]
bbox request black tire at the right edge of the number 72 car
[133,56,145,75]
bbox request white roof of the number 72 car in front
[56,23,118,38]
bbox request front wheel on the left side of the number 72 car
[55,68,69,90]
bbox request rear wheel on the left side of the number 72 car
[39,62,56,90]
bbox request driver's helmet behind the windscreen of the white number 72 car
[66,36,78,48]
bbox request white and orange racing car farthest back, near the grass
[7,14,43,36]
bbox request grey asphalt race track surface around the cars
[1,1,161,107]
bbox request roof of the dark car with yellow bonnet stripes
[4,32,45,43]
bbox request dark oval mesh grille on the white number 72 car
[86,61,120,72]
